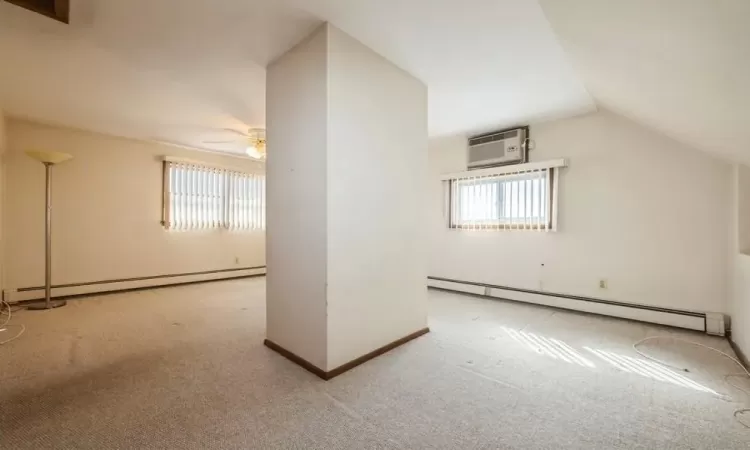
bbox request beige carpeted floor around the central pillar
[0,278,750,450]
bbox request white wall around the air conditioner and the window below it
[429,111,731,312]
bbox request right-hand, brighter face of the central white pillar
[328,23,428,369]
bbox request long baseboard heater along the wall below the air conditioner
[427,277,708,334]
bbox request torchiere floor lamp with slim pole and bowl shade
[26,151,73,310]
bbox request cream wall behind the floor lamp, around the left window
[3,119,265,289]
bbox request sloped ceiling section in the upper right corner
[541,0,750,164]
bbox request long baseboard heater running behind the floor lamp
[3,266,266,303]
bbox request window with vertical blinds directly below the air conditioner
[443,162,564,230]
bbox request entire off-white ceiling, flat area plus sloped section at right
[0,0,750,164]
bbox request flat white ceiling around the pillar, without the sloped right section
[0,0,595,152]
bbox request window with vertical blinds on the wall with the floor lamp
[162,159,266,230]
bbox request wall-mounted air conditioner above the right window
[467,127,529,169]
